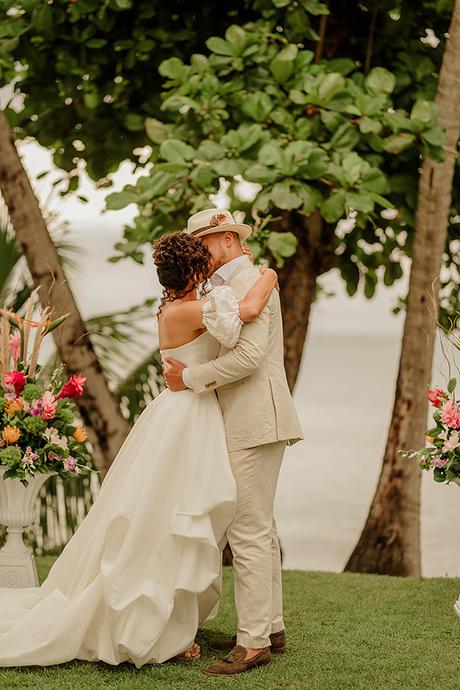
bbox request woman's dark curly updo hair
[152,232,212,313]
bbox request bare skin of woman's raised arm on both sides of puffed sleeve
[176,268,278,330]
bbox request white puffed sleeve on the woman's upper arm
[203,285,243,348]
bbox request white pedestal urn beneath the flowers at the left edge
[0,467,51,587]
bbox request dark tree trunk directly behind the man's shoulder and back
[278,211,333,390]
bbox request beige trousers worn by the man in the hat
[227,441,286,649]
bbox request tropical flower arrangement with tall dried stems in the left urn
[0,298,90,486]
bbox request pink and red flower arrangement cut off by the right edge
[401,330,460,482]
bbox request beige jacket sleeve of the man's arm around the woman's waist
[188,299,272,393]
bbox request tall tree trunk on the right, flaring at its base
[345,0,460,575]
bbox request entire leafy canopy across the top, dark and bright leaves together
[0,0,460,323]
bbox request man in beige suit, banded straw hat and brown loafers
[164,208,302,675]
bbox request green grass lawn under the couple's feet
[0,557,460,690]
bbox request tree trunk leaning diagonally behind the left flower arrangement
[0,111,128,474]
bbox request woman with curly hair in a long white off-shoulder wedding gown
[0,233,277,668]
